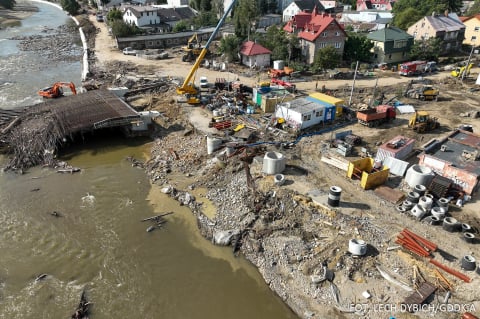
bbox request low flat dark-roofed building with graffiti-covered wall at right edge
[419,130,480,195]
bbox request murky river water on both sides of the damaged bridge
[0,4,297,319]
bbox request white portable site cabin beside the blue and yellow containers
[275,98,327,130]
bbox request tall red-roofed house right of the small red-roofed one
[298,10,347,64]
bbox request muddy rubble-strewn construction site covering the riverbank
[0,10,480,319]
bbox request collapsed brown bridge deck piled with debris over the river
[0,90,142,169]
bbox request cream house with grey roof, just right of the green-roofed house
[407,11,465,54]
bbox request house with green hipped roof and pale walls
[367,25,413,64]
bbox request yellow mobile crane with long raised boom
[176,0,237,104]
